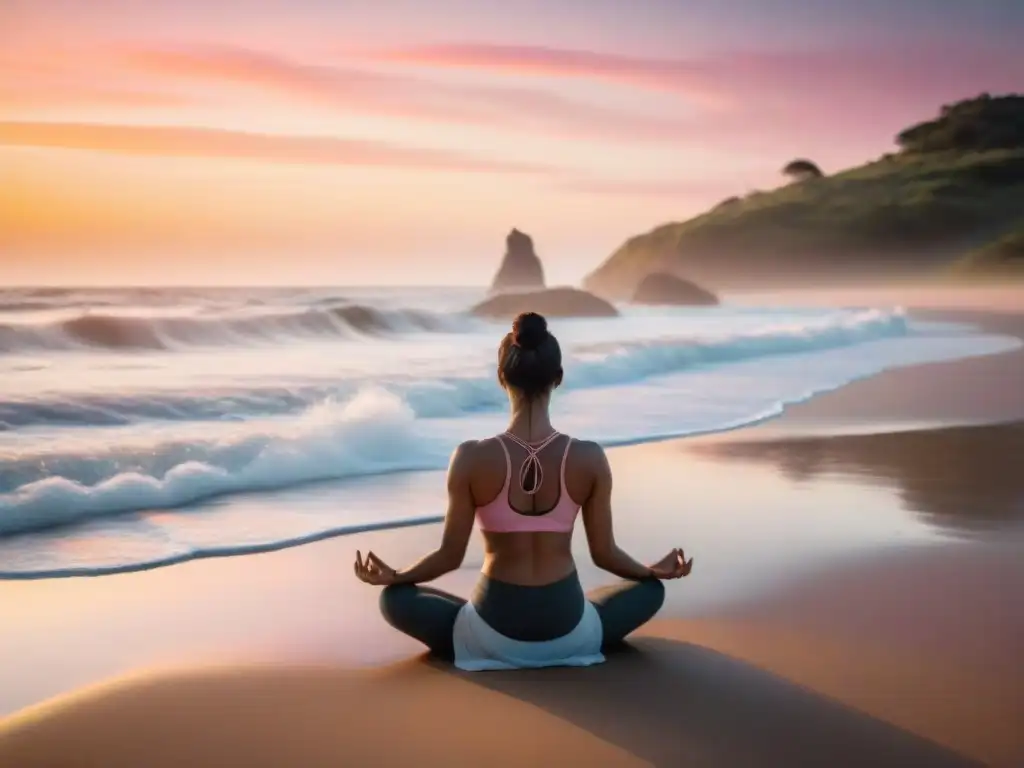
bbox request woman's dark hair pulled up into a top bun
[498,312,562,400]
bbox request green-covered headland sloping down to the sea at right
[585,95,1024,298]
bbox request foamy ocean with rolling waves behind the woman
[0,288,1019,579]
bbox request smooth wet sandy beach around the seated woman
[0,302,1024,768]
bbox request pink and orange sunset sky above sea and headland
[0,0,1024,285]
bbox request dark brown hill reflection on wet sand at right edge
[687,422,1024,536]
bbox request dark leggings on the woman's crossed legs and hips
[380,573,665,660]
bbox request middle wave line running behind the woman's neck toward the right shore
[0,309,908,434]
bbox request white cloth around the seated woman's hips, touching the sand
[452,601,604,672]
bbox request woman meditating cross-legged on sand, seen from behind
[355,312,693,670]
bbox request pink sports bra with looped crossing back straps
[476,432,580,534]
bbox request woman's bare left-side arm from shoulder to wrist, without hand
[391,442,476,584]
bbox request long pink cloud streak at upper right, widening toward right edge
[370,41,1024,117]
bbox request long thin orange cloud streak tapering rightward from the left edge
[0,121,556,174]
